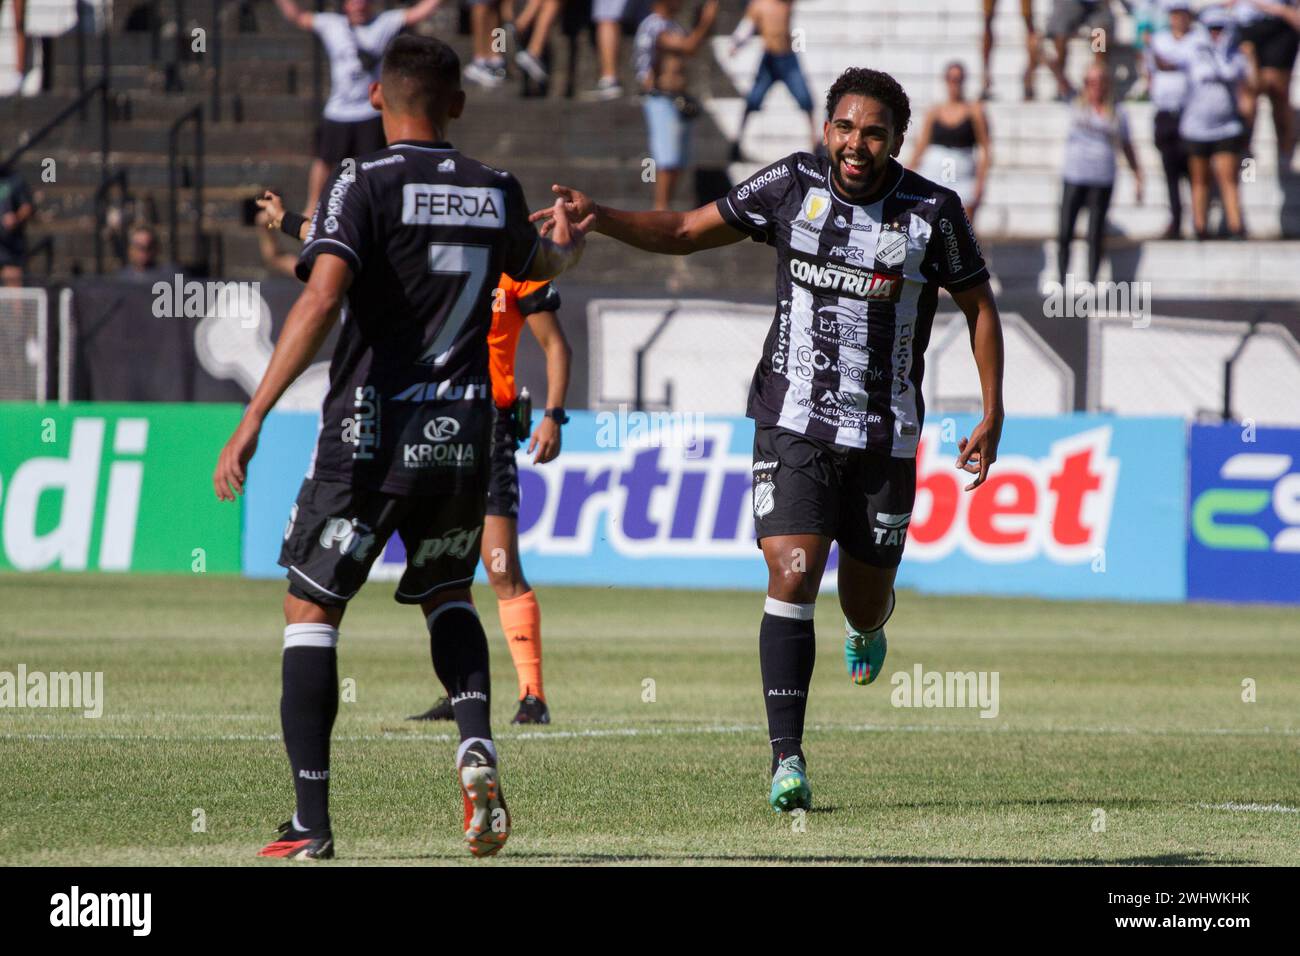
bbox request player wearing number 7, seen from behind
[213,36,590,860]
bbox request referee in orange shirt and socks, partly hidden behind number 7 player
[257,190,573,723]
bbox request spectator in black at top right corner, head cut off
[1232,0,1300,165]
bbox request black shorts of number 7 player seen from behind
[280,479,484,607]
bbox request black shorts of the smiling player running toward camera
[754,424,917,567]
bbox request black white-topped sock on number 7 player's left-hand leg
[280,624,338,831]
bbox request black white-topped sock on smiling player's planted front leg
[758,597,816,773]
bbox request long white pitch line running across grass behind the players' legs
[0,723,1300,743]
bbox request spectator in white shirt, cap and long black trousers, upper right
[1144,0,1196,239]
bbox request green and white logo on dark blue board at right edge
[1192,451,1300,554]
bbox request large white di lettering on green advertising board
[0,418,150,571]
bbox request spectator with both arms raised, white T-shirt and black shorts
[276,0,442,216]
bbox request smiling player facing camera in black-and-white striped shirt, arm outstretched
[533,69,1002,810]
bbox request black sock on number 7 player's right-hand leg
[428,601,491,740]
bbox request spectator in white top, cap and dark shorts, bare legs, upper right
[1178,7,1253,239]
